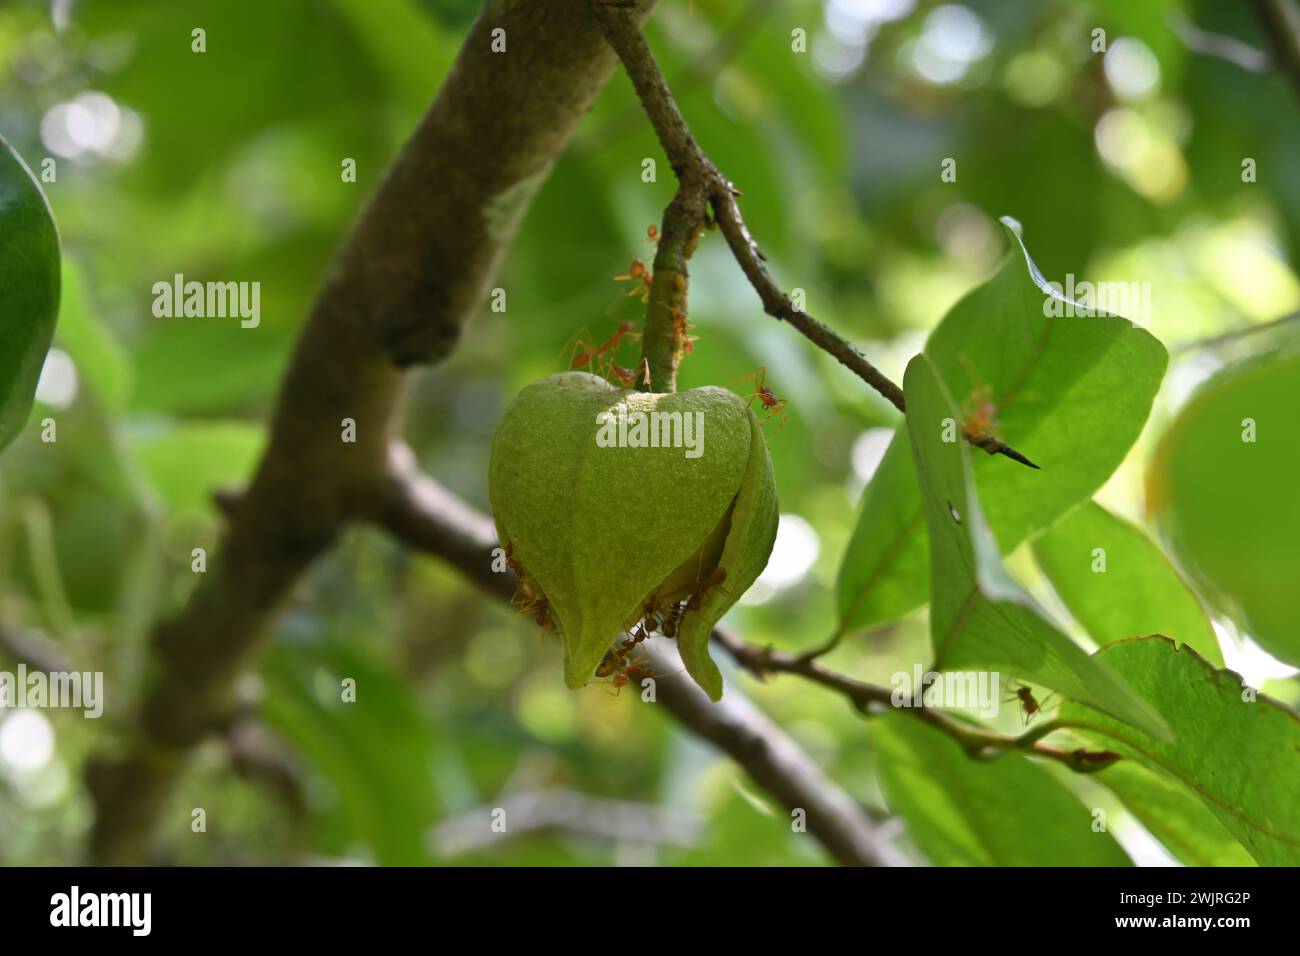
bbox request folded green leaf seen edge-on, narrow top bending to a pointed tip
[904,355,1167,735]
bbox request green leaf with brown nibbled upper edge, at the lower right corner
[1057,636,1300,866]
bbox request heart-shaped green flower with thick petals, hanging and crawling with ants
[488,372,777,700]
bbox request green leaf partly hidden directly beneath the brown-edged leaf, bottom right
[1096,760,1255,866]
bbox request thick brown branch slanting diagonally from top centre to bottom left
[87,0,650,864]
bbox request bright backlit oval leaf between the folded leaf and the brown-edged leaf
[1034,501,1223,665]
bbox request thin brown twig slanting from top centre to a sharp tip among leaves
[592,0,1039,468]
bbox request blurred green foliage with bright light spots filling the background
[0,0,1300,865]
